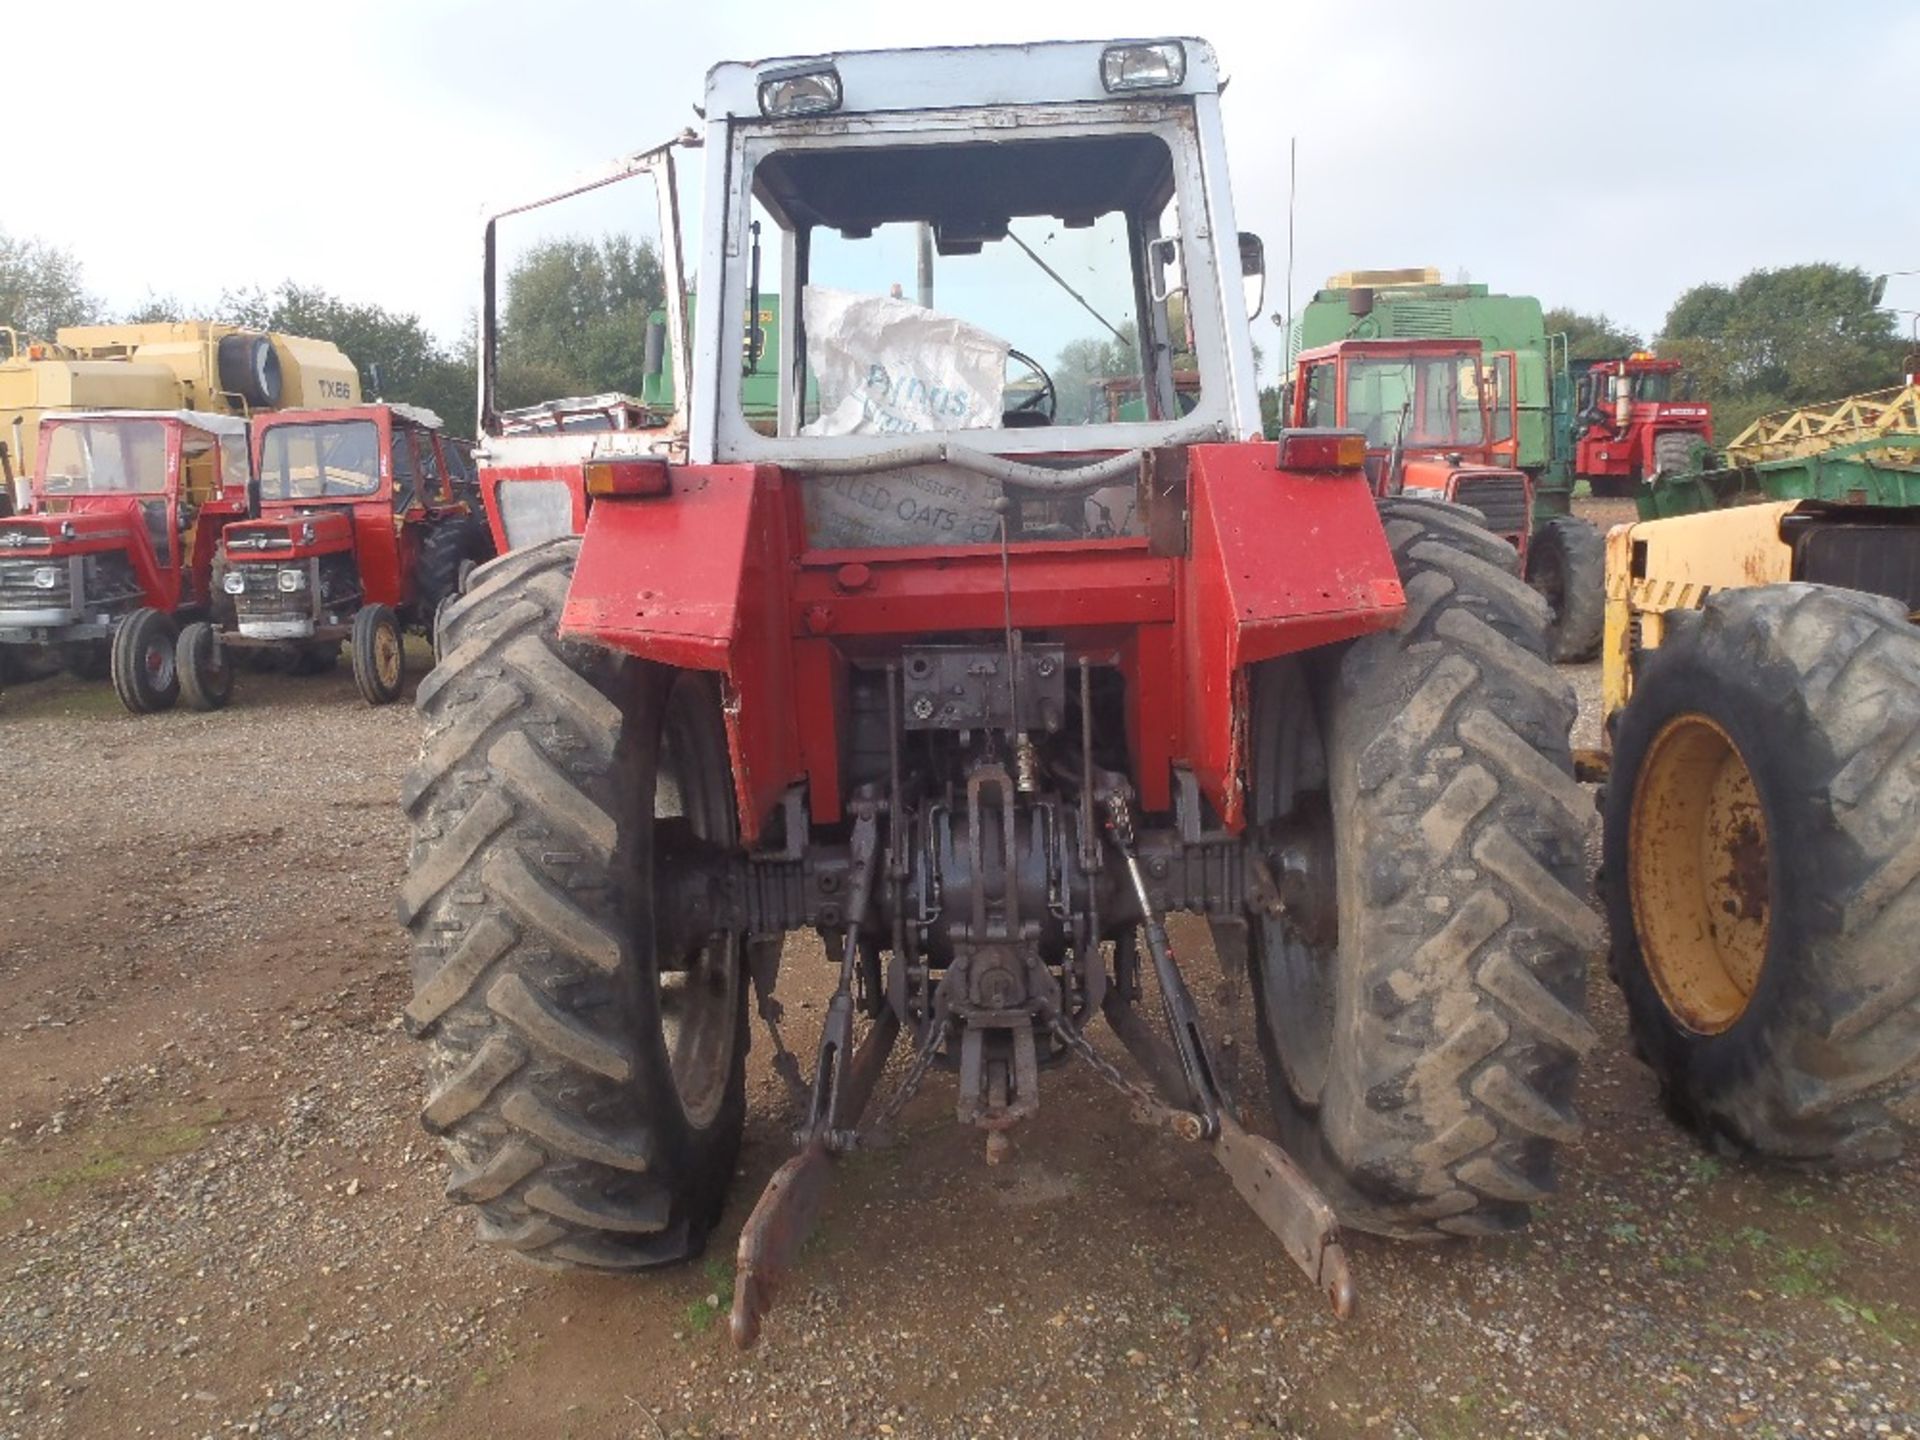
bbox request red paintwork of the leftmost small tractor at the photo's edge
[8,413,246,614]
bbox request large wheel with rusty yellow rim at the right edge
[1601,584,1920,1165]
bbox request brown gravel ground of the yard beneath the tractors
[0,545,1920,1440]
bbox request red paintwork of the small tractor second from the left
[245,405,467,611]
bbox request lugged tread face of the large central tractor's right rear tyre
[1275,499,1605,1238]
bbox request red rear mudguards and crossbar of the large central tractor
[555,444,1405,843]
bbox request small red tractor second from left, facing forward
[193,405,493,708]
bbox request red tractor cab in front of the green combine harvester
[1288,340,1534,566]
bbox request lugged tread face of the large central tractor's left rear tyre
[399,538,732,1271]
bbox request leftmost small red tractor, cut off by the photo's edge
[0,411,252,714]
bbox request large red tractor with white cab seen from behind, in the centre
[412,38,1603,1344]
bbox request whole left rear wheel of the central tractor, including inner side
[399,538,747,1269]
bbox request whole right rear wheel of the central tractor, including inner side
[1250,501,1605,1238]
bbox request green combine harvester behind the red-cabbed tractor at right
[1288,269,1605,660]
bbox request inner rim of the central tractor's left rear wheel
[653,682,741,1129]
